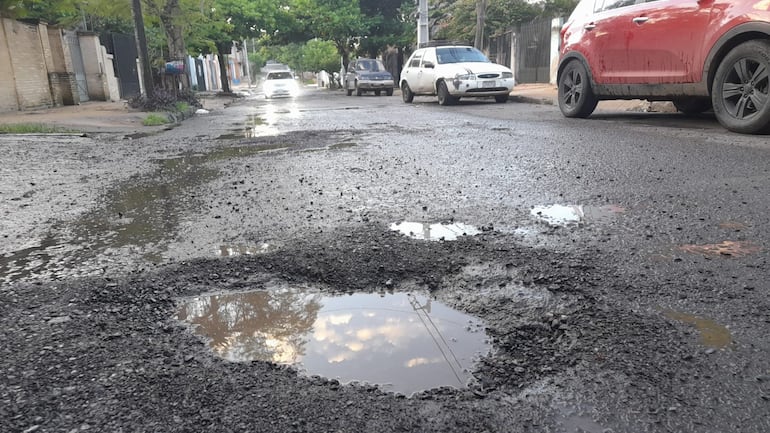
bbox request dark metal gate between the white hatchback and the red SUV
[516,18,552,83]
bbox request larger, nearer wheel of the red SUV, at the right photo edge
[711,40,770,134]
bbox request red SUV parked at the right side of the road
[558,0,770,134]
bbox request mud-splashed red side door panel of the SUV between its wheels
[592,0,713,84]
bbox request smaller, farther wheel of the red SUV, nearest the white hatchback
[558,60,599,117]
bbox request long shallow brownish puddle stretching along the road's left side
[0,143,290,282]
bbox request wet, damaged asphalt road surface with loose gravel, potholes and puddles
[0,90,770,433]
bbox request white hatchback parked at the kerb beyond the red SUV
[399,45,514,105]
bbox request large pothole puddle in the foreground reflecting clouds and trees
[176,289,490,395]
